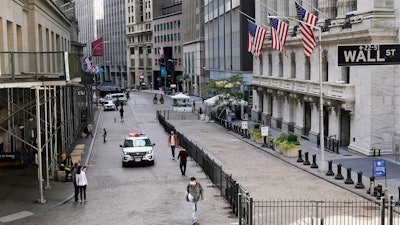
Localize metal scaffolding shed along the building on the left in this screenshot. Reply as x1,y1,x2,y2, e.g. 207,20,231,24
0,52,93,203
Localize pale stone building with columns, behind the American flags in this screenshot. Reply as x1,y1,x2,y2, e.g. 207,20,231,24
251,0,400,160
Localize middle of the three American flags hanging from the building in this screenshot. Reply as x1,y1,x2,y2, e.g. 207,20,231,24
269,18,289,52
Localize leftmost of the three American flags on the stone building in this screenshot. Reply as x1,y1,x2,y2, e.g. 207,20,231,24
247,20,267,59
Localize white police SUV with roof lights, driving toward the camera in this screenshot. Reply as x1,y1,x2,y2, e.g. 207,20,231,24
120,132,155,167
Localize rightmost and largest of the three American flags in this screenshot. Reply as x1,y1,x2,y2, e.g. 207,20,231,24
295,2,318,57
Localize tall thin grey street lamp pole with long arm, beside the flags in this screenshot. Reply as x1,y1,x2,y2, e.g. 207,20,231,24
268,16,327,172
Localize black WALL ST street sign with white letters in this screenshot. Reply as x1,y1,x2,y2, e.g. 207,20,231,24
338,44,400,66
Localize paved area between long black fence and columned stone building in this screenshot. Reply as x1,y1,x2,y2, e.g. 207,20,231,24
159,93,400,200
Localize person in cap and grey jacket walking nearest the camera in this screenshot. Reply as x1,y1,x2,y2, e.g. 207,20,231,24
186,177,204,225
